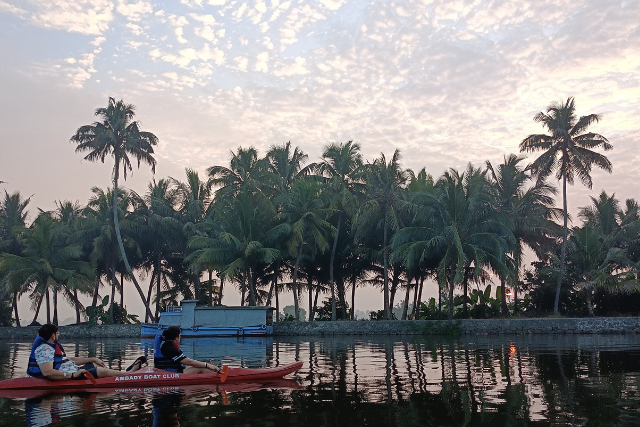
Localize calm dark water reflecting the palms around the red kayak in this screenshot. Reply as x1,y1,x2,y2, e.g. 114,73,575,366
0,335,640,427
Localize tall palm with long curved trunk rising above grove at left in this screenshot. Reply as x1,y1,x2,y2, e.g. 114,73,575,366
71,97,158,319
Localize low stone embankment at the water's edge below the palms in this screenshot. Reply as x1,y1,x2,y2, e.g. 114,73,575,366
0,317,640,341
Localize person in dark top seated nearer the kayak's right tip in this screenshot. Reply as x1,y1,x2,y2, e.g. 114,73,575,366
153,326,219,374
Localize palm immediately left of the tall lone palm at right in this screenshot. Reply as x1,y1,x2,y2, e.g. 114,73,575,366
486,154,561,316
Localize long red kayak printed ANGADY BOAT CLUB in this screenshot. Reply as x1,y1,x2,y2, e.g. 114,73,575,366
0,362,302,391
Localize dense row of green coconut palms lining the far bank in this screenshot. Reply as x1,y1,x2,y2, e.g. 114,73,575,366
0,98,640,326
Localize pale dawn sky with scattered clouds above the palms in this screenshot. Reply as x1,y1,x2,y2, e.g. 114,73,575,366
0,0,640,320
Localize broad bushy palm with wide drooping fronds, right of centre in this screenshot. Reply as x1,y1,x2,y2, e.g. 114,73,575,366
394,165,512,320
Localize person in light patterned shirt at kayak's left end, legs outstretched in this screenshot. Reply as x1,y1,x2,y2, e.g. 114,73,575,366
27,324,147,380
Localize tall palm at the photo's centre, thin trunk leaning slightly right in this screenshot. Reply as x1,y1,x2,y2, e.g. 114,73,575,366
319,141,362,320
